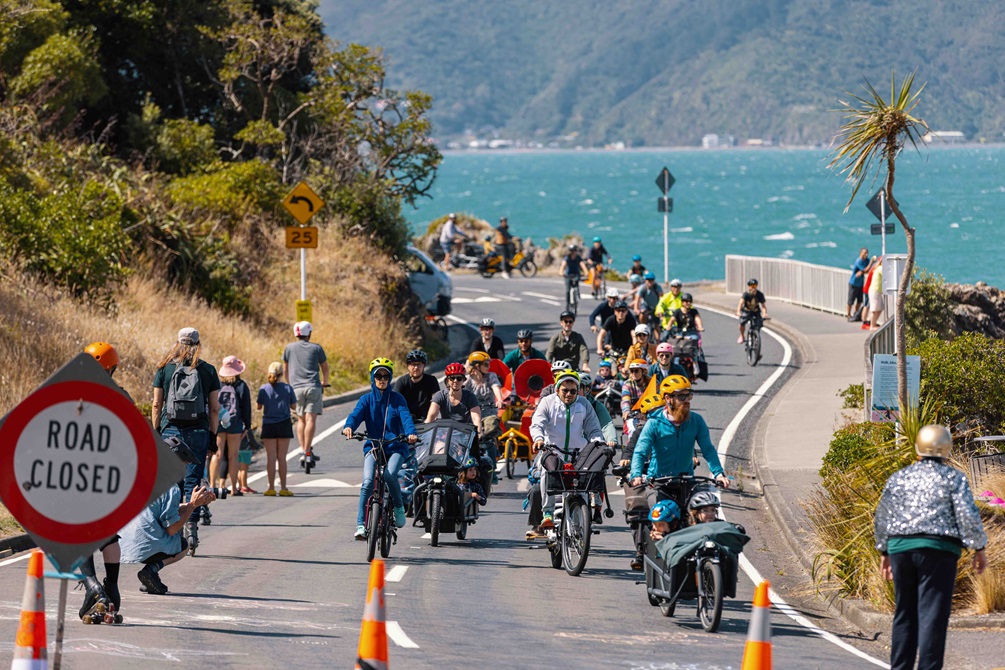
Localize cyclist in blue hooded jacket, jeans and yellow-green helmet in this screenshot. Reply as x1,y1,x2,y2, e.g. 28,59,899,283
342,358,418,540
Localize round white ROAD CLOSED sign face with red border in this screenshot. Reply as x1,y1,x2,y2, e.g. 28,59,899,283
0,381,158,544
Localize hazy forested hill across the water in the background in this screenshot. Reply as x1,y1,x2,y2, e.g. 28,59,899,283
320,0,1005,146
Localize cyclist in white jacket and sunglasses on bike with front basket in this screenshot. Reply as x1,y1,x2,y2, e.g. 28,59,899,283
531,370,605,528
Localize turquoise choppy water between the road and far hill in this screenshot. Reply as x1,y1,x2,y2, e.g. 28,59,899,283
406,147,1005,286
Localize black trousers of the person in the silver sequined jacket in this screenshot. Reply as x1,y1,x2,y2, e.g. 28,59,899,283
889,549,957,670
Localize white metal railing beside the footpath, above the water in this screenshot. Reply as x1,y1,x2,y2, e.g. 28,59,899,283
726,255,851,314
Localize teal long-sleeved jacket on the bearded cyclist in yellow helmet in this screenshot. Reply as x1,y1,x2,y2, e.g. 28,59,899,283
630,411,723,478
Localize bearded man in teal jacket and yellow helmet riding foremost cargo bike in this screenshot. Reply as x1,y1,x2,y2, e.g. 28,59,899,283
630,375,730,488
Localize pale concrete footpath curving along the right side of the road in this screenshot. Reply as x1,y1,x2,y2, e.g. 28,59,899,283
692,286,1005,668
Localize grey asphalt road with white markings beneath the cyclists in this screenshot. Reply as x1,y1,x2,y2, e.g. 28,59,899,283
0,275,892,670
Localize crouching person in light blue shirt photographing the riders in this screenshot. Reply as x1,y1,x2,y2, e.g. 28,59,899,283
119,436,216,596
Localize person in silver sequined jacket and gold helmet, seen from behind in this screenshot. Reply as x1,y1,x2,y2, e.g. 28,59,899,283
875,426,988,670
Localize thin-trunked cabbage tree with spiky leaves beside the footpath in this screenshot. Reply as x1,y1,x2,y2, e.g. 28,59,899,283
828,70,928,412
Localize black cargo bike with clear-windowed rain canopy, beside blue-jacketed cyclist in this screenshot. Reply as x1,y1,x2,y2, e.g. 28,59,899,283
413,419,478,546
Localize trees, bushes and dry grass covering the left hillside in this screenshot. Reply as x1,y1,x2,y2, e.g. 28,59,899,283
0,0,440,411
